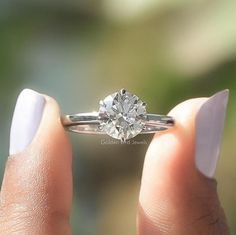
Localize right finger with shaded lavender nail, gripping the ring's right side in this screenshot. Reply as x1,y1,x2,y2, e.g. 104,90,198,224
138,91,229,235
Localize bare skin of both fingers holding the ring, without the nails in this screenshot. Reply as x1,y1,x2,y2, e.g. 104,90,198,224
0,96,230,235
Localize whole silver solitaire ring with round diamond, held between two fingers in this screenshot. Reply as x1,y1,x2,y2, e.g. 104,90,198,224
62,89,175,142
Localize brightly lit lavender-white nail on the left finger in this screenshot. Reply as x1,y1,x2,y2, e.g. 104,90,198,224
9,89,46,155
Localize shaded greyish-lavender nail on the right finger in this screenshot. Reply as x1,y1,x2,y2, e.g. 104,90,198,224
195,90,229,178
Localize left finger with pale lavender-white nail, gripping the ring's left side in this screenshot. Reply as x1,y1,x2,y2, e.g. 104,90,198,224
0,89,72,235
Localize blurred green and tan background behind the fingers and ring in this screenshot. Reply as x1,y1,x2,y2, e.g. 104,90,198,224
0,0,236,235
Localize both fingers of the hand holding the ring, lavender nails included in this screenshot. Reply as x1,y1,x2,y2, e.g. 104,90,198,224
0,90,229,235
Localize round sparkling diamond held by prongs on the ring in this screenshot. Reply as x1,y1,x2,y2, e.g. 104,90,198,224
99,89,147,141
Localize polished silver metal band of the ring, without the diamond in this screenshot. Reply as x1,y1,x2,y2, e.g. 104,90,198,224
62,112,175,134
